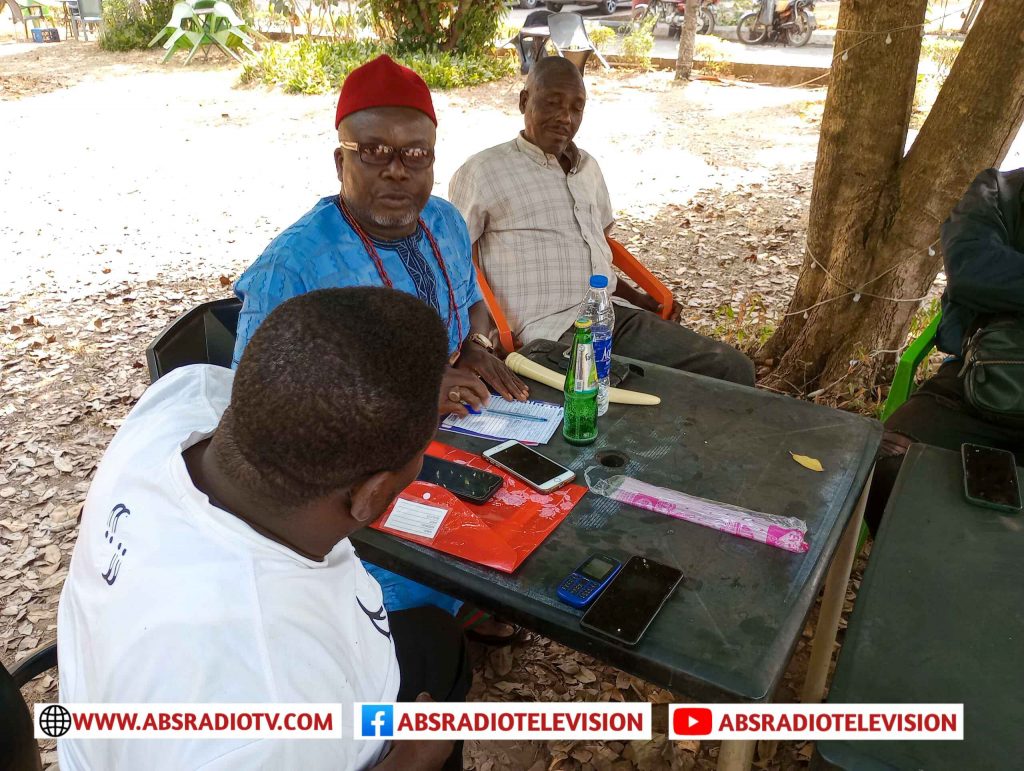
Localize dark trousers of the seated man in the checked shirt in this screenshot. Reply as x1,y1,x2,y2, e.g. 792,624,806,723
559,305,754,386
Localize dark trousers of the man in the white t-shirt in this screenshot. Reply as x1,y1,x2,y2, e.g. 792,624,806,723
388,605,473,771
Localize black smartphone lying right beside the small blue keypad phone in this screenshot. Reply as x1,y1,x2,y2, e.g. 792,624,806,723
580,557,683,645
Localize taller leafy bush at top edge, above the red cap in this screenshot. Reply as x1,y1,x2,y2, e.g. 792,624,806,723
367,0,508,54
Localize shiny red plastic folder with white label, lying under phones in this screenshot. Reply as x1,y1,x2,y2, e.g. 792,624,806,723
371,441,587,573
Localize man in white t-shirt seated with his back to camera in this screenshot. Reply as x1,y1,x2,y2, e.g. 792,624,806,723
57,288,470,771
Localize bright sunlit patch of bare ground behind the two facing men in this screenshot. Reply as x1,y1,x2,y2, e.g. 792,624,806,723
0,52,820,296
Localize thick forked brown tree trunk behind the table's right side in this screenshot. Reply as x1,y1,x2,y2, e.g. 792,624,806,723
762,0,1024,392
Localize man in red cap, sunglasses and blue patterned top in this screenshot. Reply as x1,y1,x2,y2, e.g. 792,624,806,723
234,56,527,630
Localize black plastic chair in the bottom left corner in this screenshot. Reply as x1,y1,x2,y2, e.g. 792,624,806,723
0,643,57,771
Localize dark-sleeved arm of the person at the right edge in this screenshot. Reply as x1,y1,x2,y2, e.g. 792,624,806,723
942,169,1024,313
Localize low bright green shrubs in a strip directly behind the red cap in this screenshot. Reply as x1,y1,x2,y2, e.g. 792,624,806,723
242,38,515,94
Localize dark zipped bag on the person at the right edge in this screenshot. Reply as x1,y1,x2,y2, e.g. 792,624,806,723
961,315,1024,428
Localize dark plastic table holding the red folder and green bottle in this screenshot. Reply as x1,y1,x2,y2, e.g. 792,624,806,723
351,346,882,767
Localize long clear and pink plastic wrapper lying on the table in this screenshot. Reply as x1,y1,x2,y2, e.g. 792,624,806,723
590,475,811,554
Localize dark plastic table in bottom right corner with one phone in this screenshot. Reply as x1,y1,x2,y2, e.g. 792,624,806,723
817,444,1024,771
